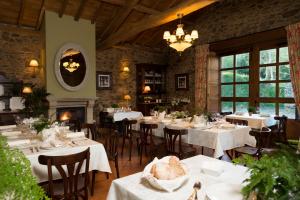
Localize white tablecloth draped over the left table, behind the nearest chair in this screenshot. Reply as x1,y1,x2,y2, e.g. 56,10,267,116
22,139,111,182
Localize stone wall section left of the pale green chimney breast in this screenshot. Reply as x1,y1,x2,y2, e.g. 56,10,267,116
0,25,45,86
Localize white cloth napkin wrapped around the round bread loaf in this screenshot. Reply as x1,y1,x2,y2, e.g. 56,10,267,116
142,156,189,192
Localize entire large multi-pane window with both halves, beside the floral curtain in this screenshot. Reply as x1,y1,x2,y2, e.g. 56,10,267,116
220,46,296,118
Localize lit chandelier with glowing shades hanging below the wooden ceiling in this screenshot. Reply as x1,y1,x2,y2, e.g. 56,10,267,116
163,14,198,53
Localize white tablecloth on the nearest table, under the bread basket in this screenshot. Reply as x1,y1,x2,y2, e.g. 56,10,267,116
107,155,249,200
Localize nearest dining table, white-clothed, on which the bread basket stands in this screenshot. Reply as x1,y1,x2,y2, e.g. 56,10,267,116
107,155,249,200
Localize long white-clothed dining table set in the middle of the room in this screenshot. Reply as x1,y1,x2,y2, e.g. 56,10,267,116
135,116,256,158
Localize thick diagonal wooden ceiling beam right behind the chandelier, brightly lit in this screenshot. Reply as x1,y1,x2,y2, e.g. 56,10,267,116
97,0,219,49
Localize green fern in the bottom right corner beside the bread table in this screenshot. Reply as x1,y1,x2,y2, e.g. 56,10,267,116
234,145,300,200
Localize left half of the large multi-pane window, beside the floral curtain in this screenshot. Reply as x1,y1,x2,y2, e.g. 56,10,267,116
220,52,250,112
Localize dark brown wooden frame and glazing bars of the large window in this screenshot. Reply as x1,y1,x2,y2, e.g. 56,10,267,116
219,42,298,119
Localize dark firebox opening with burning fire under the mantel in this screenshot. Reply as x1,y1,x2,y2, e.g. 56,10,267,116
56,107,86,123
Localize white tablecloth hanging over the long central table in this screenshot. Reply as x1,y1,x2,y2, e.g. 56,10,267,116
137,119,256,158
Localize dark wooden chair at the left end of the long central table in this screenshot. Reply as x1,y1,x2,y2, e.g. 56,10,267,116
137,123,158,165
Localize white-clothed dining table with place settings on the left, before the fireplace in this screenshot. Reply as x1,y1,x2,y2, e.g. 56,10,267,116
0,125,111,183
